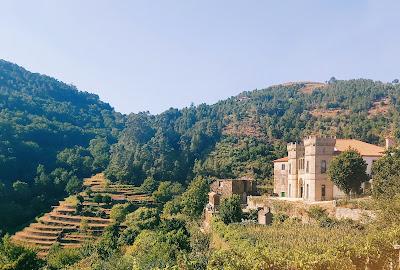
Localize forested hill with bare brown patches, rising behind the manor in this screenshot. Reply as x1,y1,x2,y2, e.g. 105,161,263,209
107,79,400,188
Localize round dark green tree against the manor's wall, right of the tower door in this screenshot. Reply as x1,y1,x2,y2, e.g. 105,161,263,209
328,149,369,196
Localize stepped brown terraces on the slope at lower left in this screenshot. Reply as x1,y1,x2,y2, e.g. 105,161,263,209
12,174,152,257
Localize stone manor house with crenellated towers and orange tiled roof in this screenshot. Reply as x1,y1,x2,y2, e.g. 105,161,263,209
274,136,393,201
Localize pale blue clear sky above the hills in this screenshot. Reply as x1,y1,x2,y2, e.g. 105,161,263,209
0,0,400,113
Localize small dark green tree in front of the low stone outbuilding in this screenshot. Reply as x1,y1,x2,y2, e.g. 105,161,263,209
219,194,243,224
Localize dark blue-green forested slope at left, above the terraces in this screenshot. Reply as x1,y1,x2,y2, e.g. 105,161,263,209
0,60,123,233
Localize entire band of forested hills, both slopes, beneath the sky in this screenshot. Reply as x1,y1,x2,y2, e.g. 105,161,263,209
0,61,400,236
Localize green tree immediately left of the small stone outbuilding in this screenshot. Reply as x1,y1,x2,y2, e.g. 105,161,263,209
181,177,210,218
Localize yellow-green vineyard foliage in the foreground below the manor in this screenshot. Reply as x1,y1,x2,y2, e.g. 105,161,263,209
208,221,400,270
